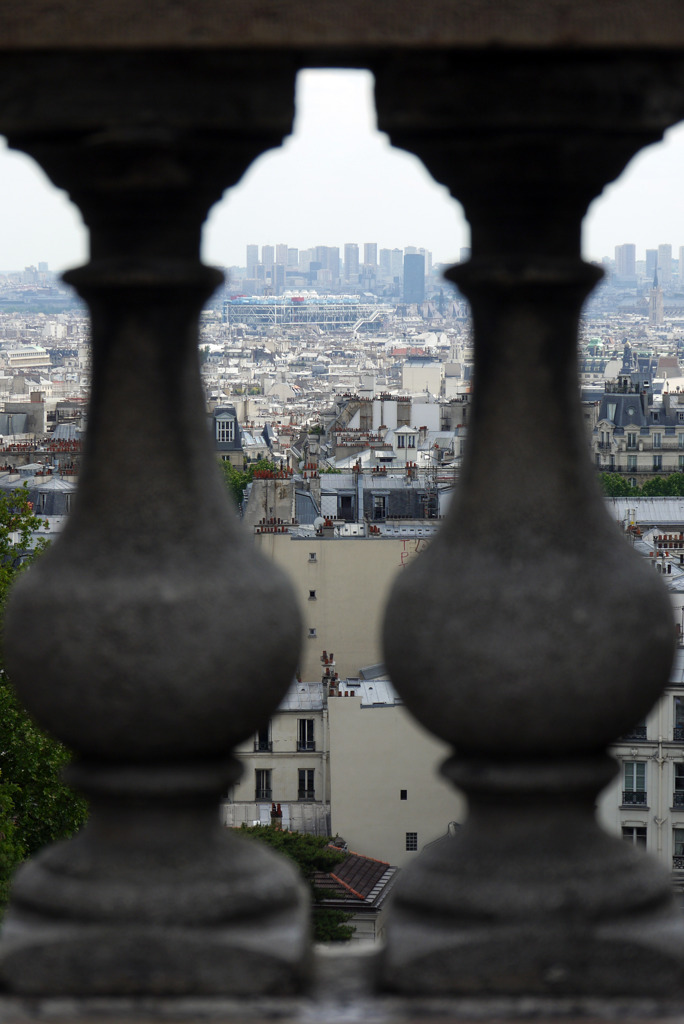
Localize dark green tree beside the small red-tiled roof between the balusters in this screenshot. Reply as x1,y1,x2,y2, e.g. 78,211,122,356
240,825,354,942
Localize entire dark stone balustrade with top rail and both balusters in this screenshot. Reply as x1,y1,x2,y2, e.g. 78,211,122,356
0,0,684,1019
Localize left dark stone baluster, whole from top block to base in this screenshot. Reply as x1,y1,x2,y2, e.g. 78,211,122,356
0,54,308,995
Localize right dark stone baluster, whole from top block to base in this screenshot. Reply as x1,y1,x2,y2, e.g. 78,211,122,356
378,53,684,994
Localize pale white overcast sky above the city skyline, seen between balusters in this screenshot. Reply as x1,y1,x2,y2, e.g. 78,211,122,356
0,71,684,270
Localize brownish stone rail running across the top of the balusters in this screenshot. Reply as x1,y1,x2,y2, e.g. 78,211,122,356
0,0,684,50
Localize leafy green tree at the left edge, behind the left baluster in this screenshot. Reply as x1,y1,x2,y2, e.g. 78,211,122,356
0,485,87,913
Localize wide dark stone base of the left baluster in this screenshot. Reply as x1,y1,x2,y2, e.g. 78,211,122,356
0,765,310,995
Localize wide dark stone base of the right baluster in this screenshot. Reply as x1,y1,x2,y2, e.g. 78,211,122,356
380,757,684,997
